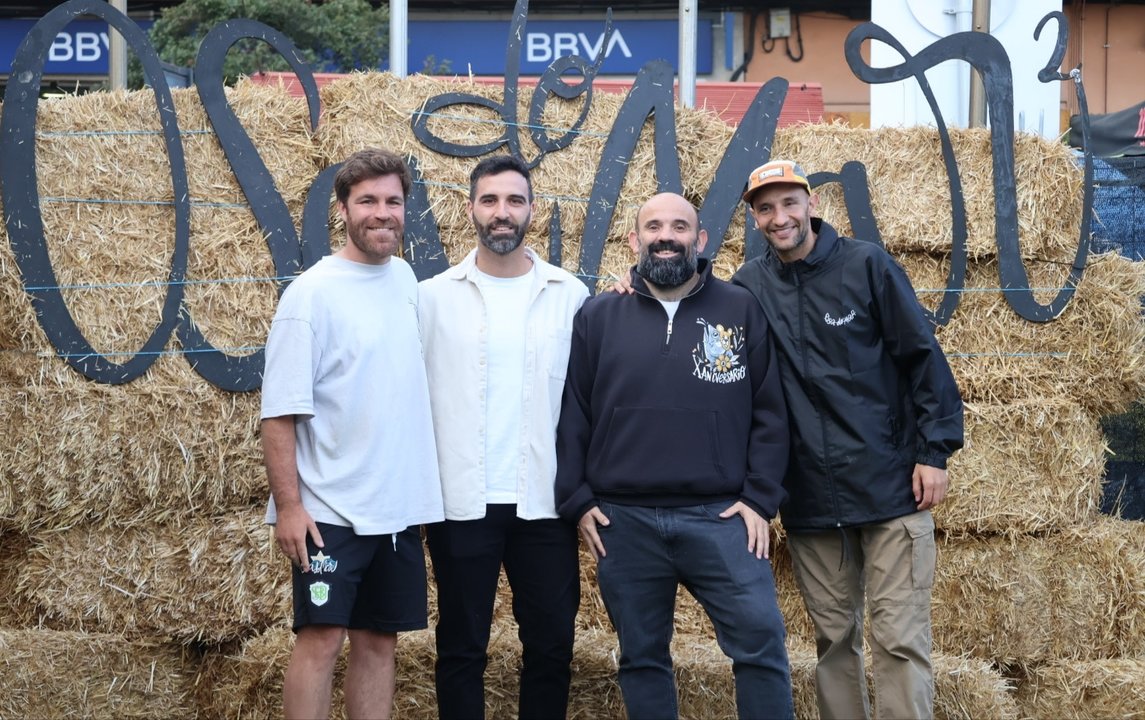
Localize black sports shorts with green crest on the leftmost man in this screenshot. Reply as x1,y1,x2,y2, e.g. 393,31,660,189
293,522,428,633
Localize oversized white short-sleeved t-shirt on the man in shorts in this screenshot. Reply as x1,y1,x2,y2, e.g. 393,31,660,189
261,255,444,535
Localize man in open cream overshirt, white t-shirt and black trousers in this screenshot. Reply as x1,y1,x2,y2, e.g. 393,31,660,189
420,155,589,720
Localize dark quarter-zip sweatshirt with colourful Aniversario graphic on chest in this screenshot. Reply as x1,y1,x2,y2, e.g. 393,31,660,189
555,260,790,522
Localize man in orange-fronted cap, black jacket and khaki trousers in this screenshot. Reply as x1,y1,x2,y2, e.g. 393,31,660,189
733,160,963,720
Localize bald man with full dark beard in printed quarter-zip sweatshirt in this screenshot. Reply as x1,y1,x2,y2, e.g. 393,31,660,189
555,193,793,720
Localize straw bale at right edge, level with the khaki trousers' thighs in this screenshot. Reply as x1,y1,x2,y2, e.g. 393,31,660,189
931,519,1145,664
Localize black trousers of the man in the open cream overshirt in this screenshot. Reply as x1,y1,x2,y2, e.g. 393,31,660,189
426,505,581,720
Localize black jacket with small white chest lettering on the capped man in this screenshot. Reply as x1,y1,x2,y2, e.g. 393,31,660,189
732,217,963,530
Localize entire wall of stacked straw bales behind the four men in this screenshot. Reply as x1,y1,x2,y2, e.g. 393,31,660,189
0,73,1145,718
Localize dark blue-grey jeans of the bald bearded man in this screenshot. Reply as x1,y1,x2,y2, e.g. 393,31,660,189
597,503,795,720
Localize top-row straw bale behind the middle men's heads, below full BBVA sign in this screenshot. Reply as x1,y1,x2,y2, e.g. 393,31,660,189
316,73,743,275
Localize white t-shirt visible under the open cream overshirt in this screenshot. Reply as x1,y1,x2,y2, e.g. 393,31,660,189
477,269,534,505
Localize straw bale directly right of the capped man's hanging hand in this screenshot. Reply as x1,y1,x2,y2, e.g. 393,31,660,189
934,399,1105,536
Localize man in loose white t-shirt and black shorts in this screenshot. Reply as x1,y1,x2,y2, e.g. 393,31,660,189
261,149,443,718
